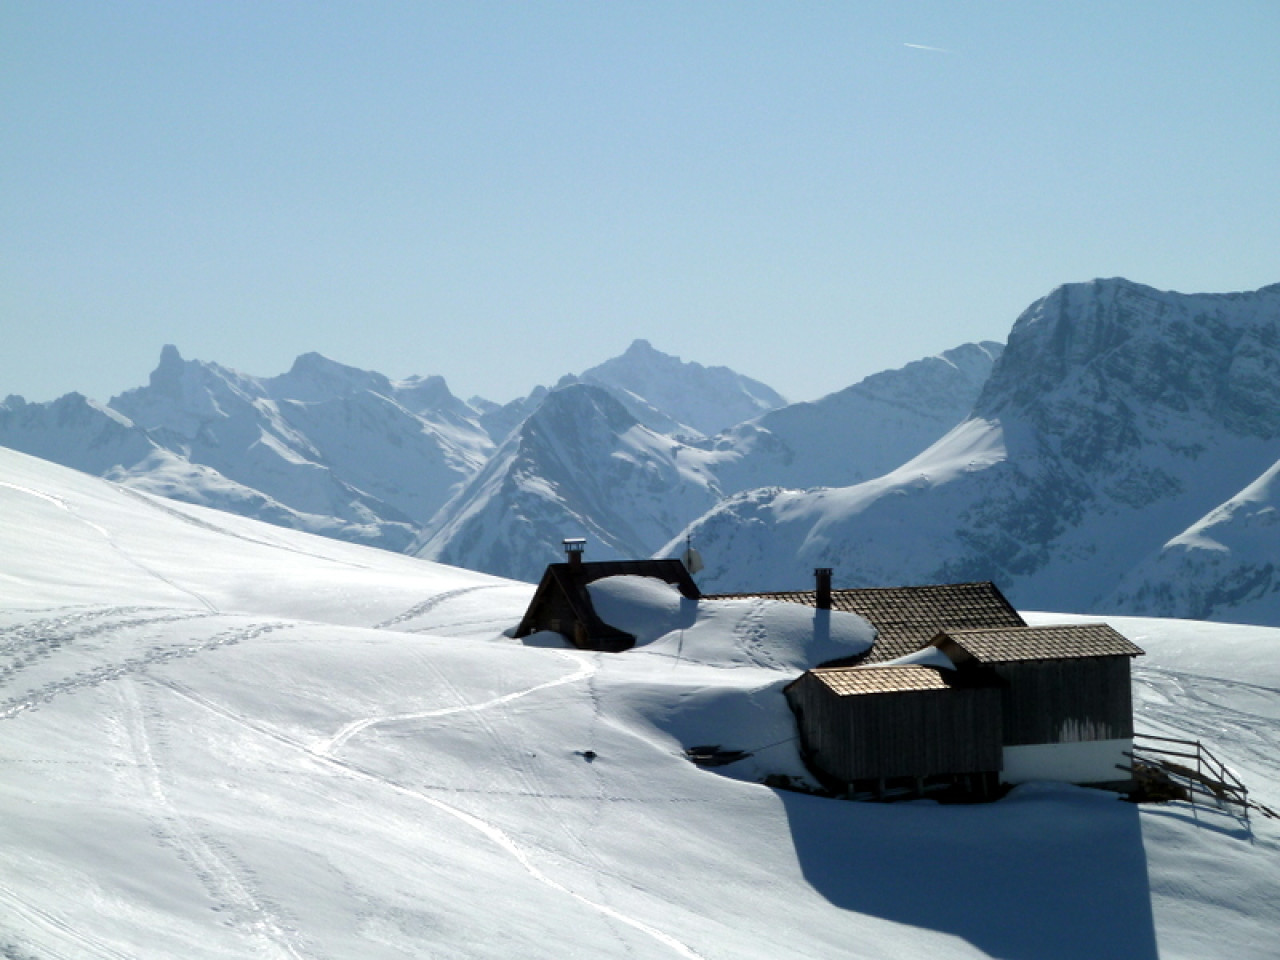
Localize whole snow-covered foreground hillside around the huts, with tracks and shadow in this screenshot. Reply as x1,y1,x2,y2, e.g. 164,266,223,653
0,449,1280,960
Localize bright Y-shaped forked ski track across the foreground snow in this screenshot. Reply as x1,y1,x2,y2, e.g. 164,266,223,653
156,650,705,960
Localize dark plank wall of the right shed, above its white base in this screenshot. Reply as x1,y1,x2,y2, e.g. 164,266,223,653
989,657,1133,746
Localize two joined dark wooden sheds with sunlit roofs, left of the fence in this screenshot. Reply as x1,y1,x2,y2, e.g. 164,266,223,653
785,623,1142,796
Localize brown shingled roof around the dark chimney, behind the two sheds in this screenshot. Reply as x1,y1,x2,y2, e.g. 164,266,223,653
709,581,1027,663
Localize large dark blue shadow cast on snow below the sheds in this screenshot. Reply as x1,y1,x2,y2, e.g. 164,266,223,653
778,785,1157,960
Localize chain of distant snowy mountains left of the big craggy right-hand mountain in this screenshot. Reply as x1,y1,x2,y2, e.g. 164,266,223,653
0,340,998,579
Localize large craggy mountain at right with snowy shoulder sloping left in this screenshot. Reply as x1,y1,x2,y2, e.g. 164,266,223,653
667,280,1280,616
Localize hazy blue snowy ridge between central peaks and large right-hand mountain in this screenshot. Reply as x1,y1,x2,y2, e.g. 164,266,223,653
713,340,1004,493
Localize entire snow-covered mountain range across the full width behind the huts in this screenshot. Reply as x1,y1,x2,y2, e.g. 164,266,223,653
0,279,1280,623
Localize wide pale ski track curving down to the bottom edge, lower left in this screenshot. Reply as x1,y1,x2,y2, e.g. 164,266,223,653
120,677,303,960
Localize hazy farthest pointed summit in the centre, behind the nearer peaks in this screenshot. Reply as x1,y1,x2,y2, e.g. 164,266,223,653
579,340,786,435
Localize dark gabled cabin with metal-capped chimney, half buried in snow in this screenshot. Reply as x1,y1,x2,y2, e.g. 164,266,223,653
515,539,701,653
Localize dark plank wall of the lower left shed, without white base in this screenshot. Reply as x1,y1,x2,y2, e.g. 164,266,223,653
786,675,1001,782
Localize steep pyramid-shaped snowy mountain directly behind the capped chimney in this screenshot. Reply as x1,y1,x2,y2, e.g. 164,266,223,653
413,383,718,580
